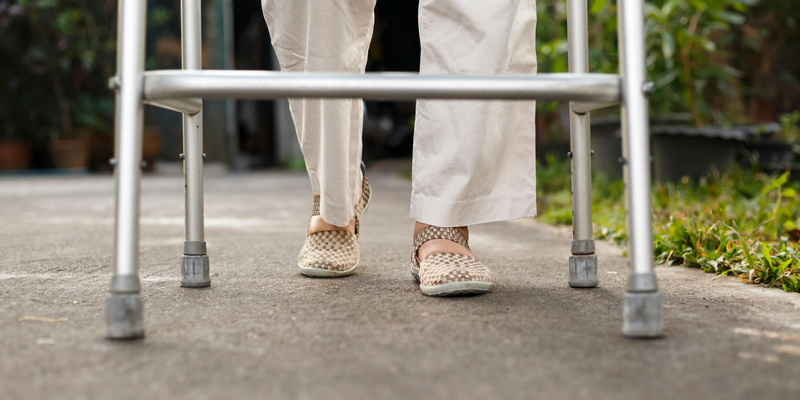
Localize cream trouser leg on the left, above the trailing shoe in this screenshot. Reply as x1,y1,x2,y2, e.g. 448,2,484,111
261,0,375,226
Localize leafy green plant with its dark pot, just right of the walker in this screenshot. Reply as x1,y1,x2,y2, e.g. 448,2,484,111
646,0,774,181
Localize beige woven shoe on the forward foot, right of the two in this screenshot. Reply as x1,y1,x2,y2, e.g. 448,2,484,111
411,226,492,296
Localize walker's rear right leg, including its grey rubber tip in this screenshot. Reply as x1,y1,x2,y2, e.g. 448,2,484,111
567,0,599,288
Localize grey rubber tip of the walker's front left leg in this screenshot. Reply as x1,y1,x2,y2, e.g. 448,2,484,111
106,293,144,340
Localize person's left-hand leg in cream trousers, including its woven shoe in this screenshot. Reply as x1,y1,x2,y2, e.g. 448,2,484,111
262,0,375,276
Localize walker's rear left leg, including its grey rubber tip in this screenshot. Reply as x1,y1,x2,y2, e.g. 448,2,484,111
181,0,211,288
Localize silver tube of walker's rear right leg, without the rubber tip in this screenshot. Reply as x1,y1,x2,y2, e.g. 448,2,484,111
567,0,593,241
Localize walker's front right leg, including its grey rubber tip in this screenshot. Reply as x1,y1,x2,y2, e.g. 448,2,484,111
617,0,664,338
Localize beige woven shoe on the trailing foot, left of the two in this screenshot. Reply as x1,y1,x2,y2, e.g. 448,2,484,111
297,165,372,278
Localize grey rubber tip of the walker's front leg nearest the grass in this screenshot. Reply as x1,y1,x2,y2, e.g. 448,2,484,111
622,292,664,339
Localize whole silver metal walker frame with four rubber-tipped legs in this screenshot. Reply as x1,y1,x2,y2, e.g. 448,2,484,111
106,0,663,339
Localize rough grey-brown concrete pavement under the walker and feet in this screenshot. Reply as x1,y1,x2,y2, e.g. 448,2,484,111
0,164,800,400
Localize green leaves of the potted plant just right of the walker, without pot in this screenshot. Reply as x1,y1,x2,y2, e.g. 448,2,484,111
645,0,757,127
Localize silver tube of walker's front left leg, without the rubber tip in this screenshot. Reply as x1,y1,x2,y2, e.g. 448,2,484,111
114,0,147,276
